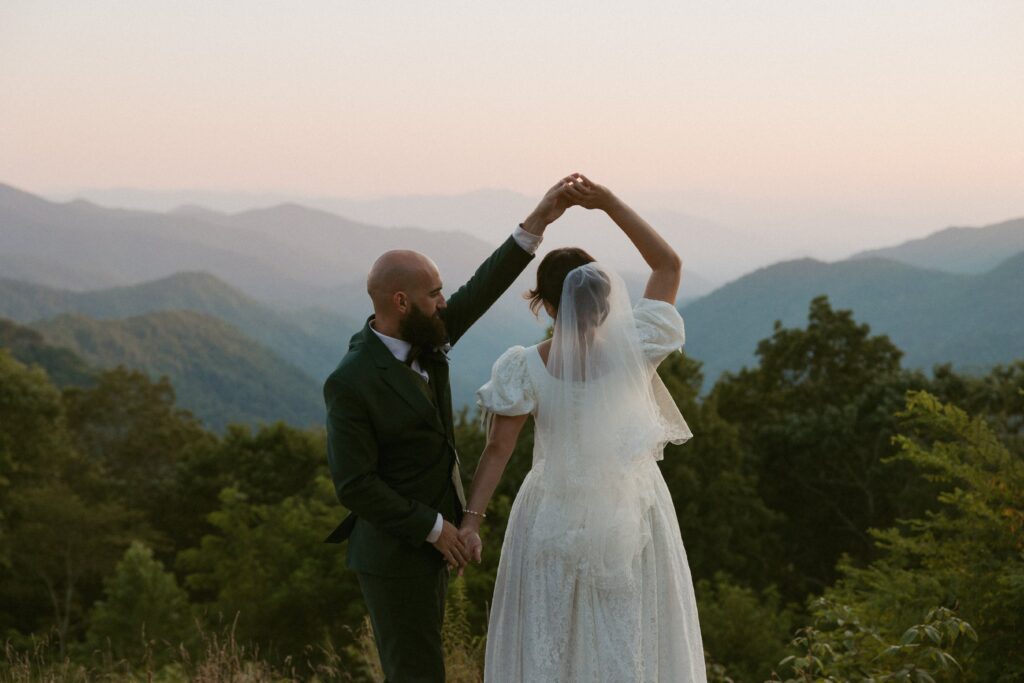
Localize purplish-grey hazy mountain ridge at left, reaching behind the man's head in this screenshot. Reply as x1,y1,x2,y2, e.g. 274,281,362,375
0,185,499,310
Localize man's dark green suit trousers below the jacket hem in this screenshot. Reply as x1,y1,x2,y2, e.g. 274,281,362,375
357,567,449,683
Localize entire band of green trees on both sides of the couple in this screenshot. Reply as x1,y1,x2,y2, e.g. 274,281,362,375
0,298,1024,683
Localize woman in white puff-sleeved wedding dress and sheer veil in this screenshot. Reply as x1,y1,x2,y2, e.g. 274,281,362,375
462,176,706,683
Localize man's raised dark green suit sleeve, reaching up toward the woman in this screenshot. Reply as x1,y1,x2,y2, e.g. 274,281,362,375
443,238,534,345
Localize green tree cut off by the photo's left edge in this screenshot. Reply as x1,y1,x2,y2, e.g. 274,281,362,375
0,350,138,652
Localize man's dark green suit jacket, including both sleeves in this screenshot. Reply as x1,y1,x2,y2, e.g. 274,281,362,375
324,238,534,577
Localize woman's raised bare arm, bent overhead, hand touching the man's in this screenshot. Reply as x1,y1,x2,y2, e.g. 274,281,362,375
565,174,683,304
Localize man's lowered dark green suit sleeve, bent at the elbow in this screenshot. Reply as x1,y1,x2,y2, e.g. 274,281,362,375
324,380,437,546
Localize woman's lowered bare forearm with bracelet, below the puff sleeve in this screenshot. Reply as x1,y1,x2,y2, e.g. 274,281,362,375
459,415,528,562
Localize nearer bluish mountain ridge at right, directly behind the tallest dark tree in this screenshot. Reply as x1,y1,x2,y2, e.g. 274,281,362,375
682,253,1024,382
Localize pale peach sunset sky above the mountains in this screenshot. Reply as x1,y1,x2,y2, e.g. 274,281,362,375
0,0,1024,245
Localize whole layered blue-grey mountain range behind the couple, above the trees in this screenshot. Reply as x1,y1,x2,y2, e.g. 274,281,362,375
0,180,1024,426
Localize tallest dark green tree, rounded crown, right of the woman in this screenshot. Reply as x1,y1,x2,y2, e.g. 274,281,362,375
711,297,923,600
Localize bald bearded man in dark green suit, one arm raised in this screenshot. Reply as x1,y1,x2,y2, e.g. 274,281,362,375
324,176,572,683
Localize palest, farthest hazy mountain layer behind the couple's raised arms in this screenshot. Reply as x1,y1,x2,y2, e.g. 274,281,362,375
48,183,724,292
